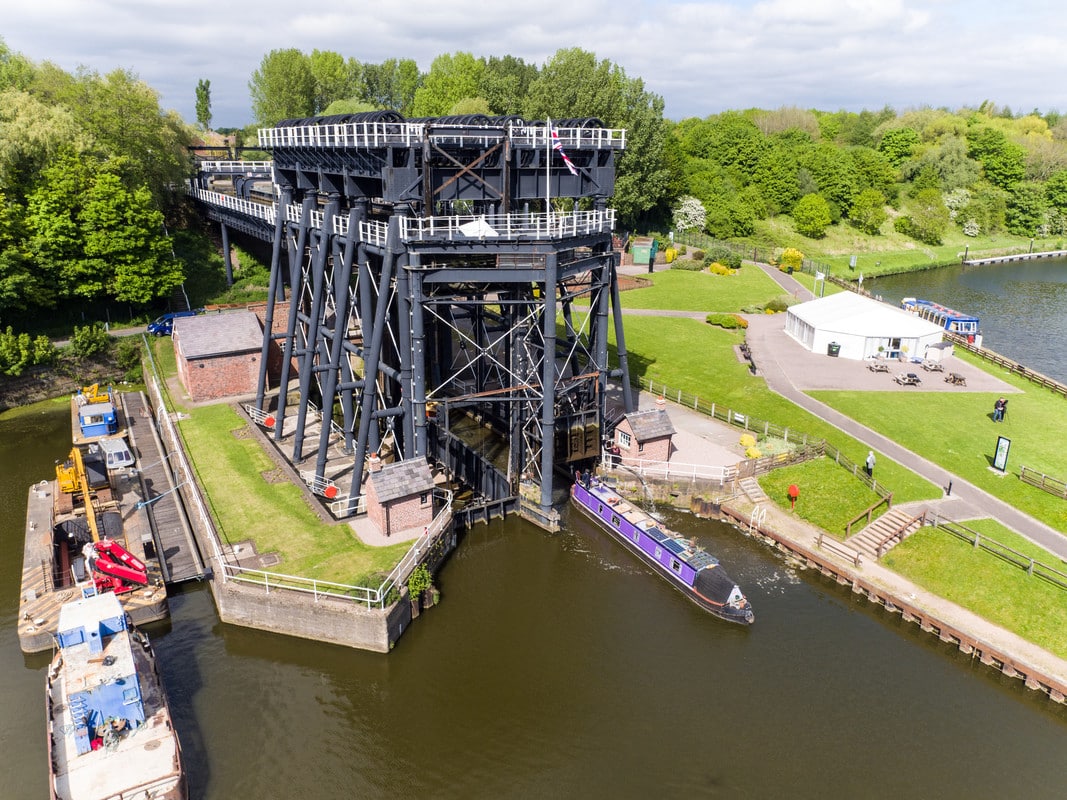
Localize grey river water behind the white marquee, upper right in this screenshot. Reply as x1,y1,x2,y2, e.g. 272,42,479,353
863,258,1067,383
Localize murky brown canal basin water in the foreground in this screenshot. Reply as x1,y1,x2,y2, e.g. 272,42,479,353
0,404,1067,800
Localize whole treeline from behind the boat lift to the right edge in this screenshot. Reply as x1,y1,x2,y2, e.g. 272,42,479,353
248,49,1067,244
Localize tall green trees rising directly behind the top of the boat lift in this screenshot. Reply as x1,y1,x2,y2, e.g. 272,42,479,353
243,48,682,228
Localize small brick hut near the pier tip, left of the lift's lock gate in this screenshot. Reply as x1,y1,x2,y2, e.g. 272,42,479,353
367,459,433,537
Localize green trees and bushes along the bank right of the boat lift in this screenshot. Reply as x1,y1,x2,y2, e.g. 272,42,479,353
671,103,1067,244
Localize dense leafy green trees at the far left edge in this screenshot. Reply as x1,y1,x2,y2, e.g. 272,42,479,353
0,39,191,330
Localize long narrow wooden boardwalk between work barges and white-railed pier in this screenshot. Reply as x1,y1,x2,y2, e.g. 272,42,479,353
121,393,206,583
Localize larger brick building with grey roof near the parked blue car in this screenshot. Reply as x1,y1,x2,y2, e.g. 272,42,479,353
173,310,264,401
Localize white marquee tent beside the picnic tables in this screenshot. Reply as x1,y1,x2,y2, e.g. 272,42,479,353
785,291,944,359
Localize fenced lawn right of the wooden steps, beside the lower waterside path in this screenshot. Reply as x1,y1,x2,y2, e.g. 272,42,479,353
882,519,1067,658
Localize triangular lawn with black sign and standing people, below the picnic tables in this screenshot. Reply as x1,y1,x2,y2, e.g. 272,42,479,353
811,367,1067,532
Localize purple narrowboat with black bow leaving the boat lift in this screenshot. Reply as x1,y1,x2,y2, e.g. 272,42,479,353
571,478,755,625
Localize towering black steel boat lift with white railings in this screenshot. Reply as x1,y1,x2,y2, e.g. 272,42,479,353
193,112,634,526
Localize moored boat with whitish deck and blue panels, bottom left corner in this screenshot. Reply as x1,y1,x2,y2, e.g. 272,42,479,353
46,592,188,800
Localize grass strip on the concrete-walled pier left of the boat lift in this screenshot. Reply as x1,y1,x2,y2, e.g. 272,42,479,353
179,404,411,587
